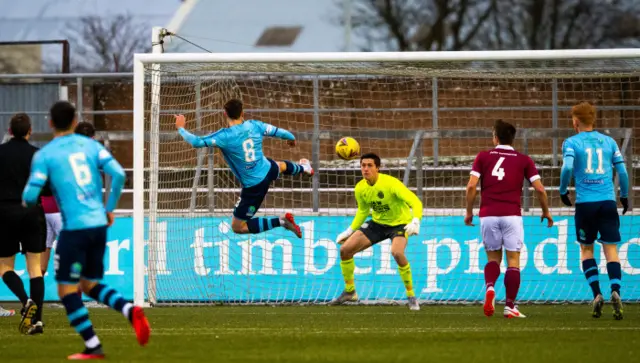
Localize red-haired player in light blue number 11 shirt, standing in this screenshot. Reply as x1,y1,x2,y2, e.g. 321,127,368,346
560,102,629,320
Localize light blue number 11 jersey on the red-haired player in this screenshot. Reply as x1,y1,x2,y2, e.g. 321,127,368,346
560,131,629,203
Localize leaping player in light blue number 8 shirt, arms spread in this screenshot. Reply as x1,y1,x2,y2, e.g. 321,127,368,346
176,99,313,238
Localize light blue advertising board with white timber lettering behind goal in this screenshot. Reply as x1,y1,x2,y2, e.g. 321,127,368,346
0,216,640,302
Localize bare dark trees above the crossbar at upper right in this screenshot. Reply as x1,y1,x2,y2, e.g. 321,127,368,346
337,0,640,51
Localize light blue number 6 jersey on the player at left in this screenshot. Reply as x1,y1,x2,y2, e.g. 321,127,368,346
22,134,125,230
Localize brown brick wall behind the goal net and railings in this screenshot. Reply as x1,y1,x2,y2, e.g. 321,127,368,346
80,77,640,167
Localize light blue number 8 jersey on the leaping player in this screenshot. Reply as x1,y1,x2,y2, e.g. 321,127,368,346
178,120,295,188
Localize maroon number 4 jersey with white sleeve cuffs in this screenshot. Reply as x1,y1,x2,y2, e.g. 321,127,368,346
471,145,540,217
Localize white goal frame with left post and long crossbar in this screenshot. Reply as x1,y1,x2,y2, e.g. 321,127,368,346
133,49,640,305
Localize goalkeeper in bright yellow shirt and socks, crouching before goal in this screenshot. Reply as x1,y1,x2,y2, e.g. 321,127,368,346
333,153,422,310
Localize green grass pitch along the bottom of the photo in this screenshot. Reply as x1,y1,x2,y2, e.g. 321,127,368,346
0,305,640,363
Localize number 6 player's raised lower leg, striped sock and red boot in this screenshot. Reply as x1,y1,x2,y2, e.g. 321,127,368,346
85,284,151,346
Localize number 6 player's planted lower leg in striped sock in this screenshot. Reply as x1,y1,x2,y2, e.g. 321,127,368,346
58,292,104,360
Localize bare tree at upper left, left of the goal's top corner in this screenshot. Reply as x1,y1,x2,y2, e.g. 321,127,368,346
66,14,151,72
